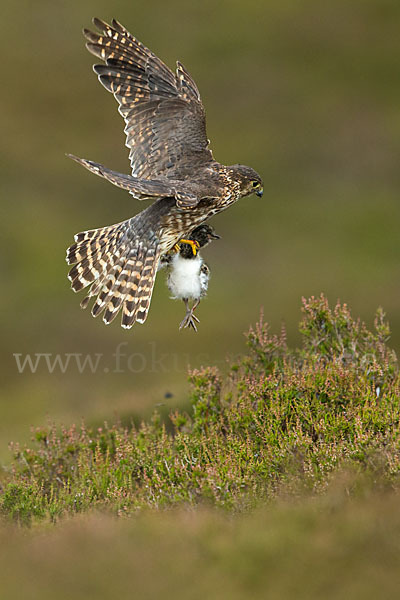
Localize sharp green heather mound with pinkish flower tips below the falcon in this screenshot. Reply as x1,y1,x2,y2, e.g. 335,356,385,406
0,296,400,524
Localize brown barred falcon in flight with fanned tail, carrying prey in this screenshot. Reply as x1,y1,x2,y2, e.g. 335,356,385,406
67,19,263,328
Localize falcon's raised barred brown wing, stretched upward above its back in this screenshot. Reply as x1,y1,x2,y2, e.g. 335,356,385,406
84,19,213,179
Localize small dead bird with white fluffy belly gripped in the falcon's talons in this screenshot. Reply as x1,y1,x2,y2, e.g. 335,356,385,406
161,224,220,331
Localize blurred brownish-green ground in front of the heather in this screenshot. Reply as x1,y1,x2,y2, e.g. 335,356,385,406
0,486,400,600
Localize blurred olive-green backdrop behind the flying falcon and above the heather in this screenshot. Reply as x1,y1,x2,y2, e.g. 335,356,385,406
0,0,400,460
